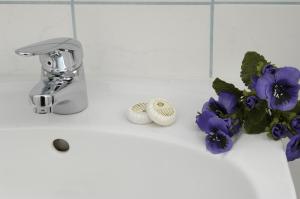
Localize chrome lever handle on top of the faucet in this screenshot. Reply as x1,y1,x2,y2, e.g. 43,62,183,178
15,38,83,73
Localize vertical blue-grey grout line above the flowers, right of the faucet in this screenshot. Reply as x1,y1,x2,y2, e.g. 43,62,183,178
209,0,215,78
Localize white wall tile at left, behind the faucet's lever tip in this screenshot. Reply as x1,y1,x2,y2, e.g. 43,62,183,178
0,4,72,76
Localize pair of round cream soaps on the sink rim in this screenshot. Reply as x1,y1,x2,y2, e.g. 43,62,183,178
127,98,176,126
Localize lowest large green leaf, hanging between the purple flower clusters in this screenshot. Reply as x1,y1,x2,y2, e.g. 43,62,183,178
244,101,271,134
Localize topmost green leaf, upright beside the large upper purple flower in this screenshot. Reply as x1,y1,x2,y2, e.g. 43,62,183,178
241,52,268,88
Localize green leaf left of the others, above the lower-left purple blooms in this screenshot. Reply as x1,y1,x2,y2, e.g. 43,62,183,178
212,78,243,98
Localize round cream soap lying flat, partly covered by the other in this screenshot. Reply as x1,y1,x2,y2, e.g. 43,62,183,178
127,102,152,124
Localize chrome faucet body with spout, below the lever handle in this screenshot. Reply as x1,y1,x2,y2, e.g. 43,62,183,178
29,68,88,115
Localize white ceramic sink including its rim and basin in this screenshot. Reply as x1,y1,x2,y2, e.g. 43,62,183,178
0,77,296,199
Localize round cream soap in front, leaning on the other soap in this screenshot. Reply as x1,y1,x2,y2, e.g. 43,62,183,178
146,98,176,126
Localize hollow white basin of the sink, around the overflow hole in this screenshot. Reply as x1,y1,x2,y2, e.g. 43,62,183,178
0,129,256,199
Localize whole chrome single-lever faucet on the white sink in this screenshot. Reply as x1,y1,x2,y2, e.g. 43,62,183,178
15,38,88,115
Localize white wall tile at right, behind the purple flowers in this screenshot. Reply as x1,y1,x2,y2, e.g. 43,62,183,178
214,5,300,85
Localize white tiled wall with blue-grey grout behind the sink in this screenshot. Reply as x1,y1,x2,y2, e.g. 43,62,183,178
0,0,300,195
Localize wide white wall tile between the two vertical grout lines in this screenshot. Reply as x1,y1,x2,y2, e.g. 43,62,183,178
75,5,209,78
